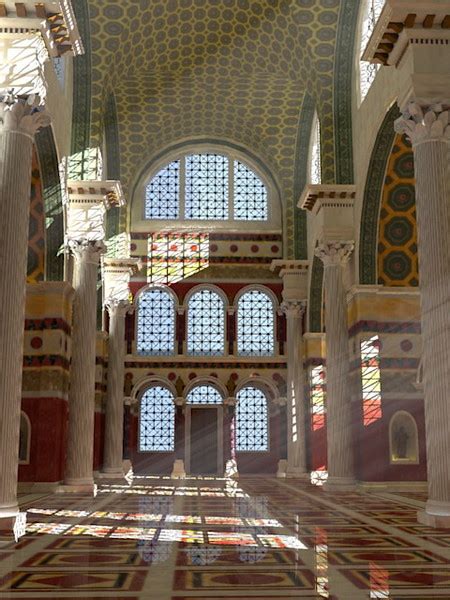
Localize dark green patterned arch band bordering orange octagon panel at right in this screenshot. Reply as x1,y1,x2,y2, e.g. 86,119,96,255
359,104,400,284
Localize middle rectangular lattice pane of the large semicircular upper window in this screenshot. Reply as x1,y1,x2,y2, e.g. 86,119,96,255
185,154,228,220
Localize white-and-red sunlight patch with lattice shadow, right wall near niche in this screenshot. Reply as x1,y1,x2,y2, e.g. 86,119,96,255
361,335,382,426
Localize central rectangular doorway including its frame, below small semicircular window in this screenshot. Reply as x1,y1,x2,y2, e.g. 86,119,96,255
185,406,223,475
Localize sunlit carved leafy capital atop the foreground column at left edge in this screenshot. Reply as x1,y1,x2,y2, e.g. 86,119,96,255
0,96,50,138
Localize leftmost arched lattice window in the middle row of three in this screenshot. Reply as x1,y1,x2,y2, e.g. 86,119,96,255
136,288,175,356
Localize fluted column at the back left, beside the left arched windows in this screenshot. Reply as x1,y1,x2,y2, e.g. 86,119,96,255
102,300,131,477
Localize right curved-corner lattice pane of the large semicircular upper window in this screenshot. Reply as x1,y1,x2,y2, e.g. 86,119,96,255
233,160,268,221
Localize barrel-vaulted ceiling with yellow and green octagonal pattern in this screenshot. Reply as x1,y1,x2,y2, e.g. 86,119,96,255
79,0,358,255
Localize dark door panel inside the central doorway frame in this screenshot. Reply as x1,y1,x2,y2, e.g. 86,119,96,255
191,408,218,475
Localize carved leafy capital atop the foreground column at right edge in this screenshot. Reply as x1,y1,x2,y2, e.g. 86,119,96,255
394,102,450,146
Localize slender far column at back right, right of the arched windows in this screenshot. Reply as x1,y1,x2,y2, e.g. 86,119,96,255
281,300,307,477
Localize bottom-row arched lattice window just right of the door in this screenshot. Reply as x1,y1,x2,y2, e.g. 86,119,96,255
236,387,269,452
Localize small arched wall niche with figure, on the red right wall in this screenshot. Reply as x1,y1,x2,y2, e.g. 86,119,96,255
389,410,420,464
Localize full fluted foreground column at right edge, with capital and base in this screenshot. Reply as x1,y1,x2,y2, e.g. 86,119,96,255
395,103,450,527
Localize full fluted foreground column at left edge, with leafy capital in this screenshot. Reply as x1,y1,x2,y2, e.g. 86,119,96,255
0,98,50,518
